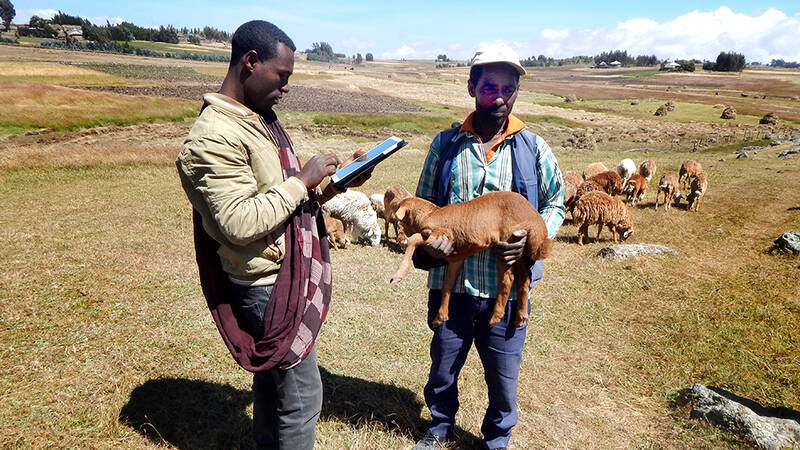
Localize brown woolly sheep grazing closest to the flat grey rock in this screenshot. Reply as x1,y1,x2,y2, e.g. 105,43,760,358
573,191,633,245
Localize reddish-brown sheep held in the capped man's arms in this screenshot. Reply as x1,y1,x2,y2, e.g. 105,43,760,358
390,191,553,328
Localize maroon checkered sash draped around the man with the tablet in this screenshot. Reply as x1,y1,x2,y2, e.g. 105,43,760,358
193,115,332,372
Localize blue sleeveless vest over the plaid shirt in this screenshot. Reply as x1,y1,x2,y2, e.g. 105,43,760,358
434,127,542,287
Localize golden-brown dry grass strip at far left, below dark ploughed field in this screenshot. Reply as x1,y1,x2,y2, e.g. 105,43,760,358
0,83,197,130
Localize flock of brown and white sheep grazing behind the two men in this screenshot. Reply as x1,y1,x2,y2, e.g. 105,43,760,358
322,158,708,248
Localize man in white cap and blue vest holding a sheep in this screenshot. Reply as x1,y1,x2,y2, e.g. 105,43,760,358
414,43,564,450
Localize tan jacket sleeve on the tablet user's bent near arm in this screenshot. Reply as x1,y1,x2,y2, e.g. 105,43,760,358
179,135,308,246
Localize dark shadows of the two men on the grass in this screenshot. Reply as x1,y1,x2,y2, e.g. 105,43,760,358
119,367,480,449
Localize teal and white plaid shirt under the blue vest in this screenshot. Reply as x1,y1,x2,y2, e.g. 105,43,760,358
416,114,564,299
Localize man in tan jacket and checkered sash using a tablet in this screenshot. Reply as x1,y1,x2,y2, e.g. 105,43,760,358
176,21,371,449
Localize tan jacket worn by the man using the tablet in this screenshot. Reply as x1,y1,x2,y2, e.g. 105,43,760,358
175,94,336,280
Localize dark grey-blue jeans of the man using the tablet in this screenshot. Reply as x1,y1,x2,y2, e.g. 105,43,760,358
234,285,322,450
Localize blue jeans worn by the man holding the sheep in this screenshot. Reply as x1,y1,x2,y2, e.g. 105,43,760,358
425,290,530,448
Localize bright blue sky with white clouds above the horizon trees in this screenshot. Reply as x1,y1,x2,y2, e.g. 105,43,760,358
12,0,800,63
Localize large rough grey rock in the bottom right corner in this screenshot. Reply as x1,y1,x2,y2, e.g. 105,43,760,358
690,384,800,450
